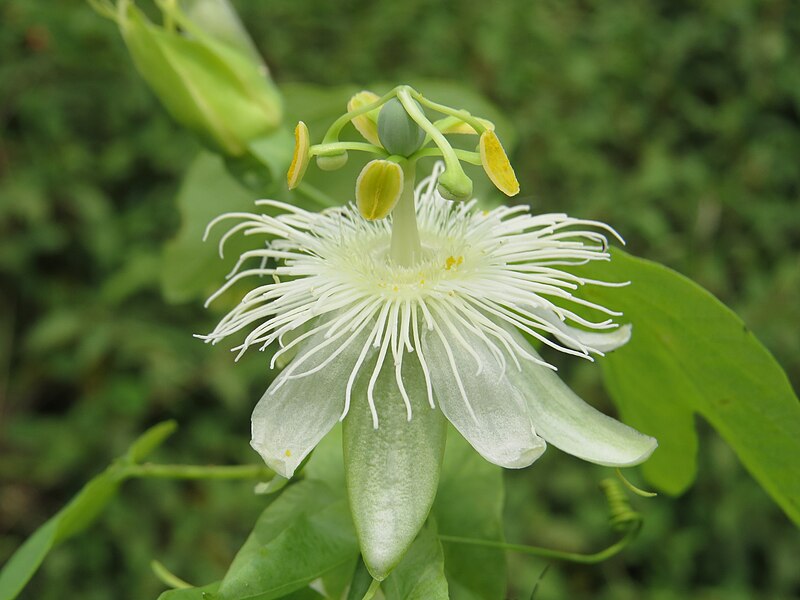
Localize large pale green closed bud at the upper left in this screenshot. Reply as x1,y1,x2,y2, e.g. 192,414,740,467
97,0,282,156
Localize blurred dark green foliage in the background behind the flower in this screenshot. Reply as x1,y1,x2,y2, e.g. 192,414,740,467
0,0,800,600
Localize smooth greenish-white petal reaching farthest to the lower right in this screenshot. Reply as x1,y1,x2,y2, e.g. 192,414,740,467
510,331,658,467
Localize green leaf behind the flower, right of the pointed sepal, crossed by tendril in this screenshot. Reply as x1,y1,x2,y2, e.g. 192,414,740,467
433,427,506,600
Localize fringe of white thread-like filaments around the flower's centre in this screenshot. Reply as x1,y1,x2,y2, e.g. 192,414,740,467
198,165,621,427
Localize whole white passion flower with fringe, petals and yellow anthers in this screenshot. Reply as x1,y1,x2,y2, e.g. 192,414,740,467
205,85,656,580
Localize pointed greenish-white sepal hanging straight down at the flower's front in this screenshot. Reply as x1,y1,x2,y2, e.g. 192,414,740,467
343,356,446,580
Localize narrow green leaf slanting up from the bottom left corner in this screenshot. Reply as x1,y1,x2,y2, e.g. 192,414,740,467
0,421,175,600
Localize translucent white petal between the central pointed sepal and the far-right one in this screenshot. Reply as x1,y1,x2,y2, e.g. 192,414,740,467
422,314,546,469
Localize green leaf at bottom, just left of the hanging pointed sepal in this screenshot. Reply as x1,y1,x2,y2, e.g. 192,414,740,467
219,480,358,600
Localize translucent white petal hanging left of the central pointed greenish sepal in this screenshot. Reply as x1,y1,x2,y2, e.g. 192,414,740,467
250,330,367,479
